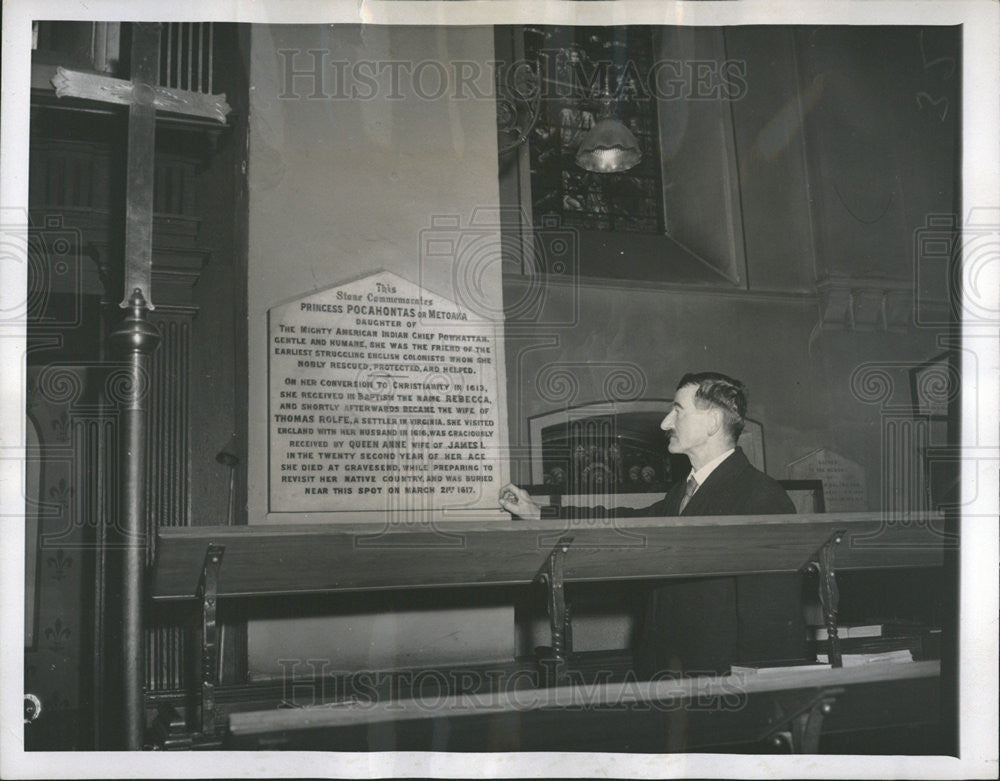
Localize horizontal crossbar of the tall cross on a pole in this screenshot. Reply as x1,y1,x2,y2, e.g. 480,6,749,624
52,67,232,124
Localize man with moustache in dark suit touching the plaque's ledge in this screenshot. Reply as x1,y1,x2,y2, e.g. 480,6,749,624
500,372,806,676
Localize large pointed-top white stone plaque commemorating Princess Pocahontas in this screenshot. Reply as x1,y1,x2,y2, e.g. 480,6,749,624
268,271,506,512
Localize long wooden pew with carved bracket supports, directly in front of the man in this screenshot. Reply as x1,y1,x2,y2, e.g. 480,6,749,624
151,513,957,746
